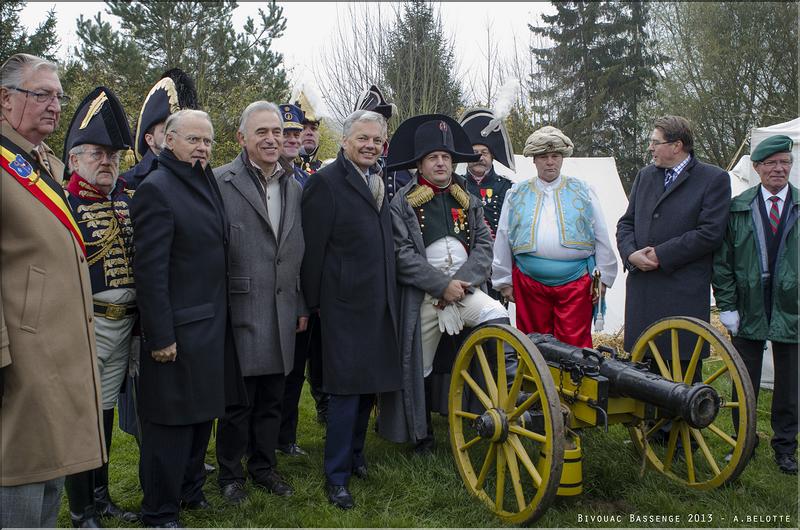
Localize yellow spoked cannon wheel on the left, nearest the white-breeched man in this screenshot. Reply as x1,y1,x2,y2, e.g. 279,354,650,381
449,325,564,524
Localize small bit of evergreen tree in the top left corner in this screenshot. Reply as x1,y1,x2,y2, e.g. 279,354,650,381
0,0,58,64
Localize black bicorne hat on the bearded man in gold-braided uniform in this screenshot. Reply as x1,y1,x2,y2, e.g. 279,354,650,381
64,86,133,164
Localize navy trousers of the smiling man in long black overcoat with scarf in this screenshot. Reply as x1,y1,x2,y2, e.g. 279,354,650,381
324,394,375,486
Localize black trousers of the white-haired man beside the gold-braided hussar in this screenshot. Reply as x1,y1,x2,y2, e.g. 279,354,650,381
139,420,213,526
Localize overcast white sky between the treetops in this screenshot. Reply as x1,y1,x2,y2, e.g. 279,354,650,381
20,2,552,93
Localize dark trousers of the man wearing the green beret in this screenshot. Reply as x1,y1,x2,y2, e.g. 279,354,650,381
733,337,800,455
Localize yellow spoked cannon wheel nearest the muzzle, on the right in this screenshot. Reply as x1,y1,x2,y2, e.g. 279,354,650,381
630,317,756,490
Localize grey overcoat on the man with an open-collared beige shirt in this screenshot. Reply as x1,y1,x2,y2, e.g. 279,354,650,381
214,154,308,377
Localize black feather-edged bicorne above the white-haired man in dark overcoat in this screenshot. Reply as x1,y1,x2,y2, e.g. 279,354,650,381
134,68,198,160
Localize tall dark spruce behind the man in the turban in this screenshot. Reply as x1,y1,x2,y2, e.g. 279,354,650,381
530,2,663,188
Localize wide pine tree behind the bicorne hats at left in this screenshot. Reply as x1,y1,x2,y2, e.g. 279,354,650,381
65,0,289,163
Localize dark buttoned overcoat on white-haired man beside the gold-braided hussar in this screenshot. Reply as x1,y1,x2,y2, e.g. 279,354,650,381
131,150,241,425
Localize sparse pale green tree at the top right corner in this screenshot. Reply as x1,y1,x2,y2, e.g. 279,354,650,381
654,2,798,168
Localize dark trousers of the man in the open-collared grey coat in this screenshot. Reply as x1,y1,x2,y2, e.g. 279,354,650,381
217,374,286,486
